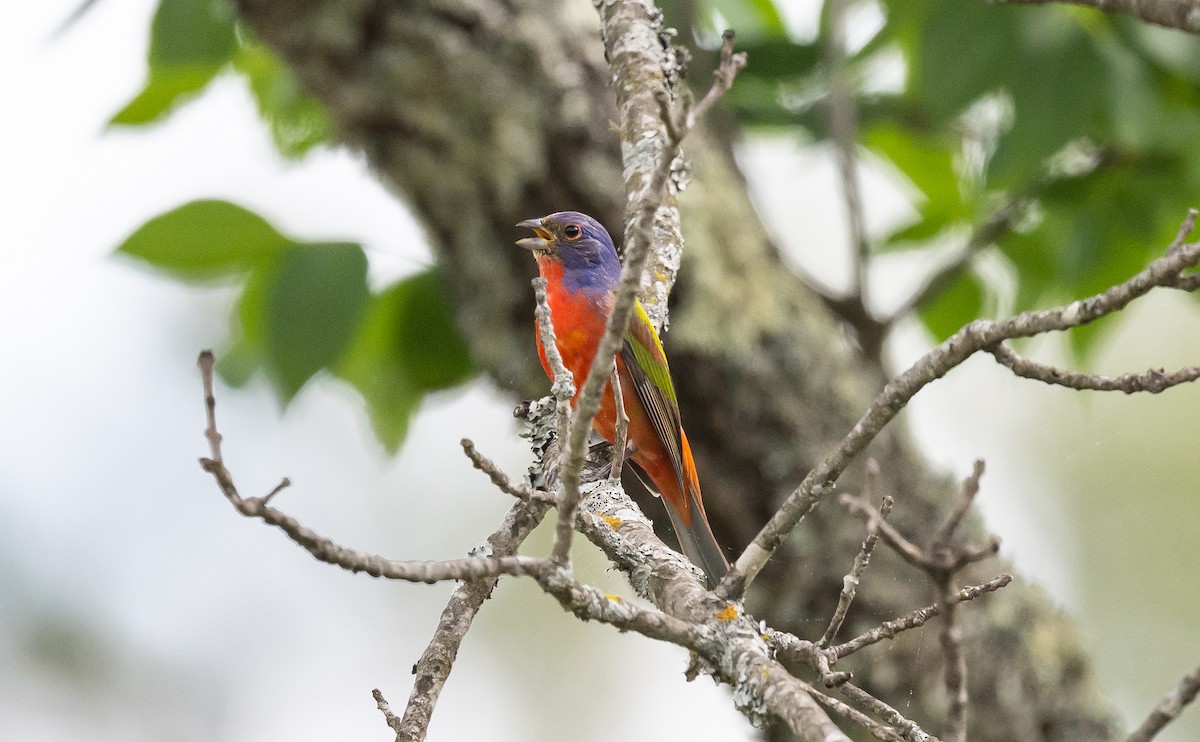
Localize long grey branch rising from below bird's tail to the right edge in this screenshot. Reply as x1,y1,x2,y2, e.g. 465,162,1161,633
719,209,1200,597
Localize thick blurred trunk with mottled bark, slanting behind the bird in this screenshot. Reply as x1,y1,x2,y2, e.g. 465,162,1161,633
231,0,1116,742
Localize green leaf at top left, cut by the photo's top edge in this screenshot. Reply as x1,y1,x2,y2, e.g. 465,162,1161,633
109,0,238,126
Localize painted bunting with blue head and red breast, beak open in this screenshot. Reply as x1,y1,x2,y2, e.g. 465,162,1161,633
517,211,730,586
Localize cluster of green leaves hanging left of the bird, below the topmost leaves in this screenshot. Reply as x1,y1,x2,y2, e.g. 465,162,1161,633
118,201,475,451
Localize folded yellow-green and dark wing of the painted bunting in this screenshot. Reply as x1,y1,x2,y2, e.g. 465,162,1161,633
620,296,685,495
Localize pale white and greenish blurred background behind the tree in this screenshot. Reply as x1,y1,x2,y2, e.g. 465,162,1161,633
0,0,1200,741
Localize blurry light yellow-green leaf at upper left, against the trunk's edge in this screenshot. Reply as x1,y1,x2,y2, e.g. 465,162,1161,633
234,43,331,158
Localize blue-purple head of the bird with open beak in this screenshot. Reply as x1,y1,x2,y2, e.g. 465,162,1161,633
517,211,620,292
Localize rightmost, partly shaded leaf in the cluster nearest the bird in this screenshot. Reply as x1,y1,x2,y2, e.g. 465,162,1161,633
337,270,475,453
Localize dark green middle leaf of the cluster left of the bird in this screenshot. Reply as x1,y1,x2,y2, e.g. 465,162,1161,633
263,243,370,401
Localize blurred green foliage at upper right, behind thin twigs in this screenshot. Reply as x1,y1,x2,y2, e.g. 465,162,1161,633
696,0,1200,343
